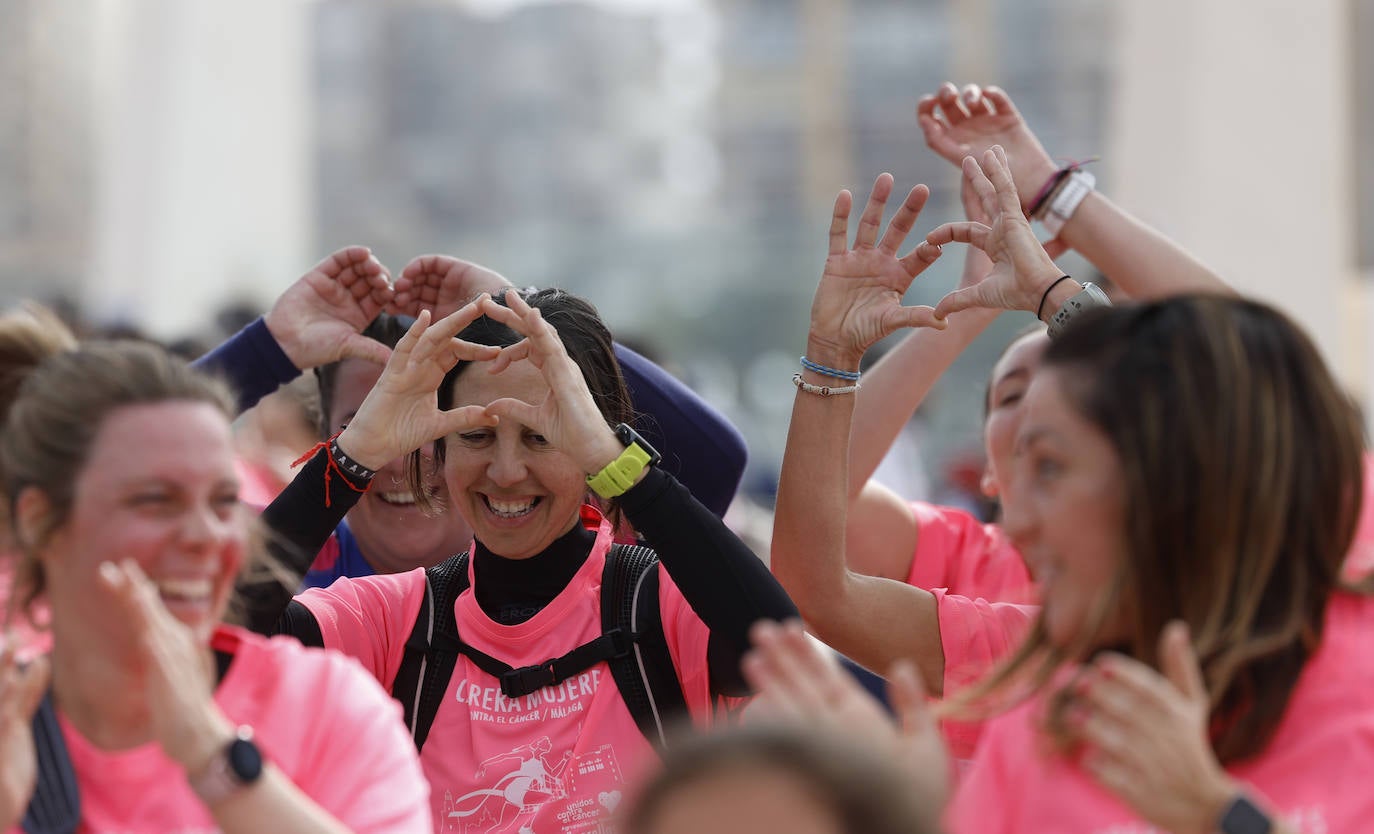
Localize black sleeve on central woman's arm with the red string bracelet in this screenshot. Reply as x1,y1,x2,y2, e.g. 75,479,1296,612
238,449,363,636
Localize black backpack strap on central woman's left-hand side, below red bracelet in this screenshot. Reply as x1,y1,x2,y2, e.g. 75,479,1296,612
392,551,469,750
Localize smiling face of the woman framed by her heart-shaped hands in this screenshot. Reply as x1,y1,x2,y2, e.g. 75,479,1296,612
444,361,587,559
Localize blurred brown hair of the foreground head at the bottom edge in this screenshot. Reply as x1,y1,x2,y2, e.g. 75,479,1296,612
625,724,938,834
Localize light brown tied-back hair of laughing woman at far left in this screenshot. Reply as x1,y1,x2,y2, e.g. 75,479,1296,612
0,311,234,607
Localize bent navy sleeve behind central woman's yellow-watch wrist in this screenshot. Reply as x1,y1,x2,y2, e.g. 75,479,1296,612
616,343,747,515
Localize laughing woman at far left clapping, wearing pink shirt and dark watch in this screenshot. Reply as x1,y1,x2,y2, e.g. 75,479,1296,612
0,321,430,834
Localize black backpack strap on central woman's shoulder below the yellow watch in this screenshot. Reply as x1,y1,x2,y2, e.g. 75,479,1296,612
602,544,687,749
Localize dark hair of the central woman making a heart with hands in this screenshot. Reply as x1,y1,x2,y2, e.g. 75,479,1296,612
408,290,635,525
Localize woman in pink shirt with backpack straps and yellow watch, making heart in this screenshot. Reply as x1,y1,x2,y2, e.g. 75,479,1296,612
254,290,796,834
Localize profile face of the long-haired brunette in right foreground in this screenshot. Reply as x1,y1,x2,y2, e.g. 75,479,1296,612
1002,368,1125,646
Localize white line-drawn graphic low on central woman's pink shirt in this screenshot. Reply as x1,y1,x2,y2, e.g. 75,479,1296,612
441,735,625,834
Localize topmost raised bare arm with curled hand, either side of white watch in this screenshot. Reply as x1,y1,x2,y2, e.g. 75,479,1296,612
916,82,1234,301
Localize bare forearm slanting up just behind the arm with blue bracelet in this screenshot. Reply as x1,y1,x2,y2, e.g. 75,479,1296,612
849,309,998,499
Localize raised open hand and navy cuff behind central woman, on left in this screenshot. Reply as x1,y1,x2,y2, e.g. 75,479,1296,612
194,246,392,411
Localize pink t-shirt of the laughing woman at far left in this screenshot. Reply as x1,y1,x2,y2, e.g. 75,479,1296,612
11,627,431,834
